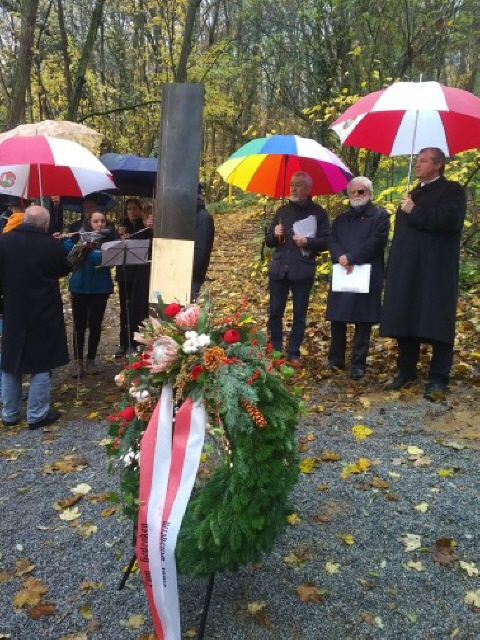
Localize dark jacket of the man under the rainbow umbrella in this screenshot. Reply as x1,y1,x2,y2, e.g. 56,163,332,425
265,198,330,282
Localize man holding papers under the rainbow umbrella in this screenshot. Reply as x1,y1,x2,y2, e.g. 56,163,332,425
265,171,330,369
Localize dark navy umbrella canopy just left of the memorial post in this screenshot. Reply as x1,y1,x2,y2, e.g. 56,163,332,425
100,153,158,198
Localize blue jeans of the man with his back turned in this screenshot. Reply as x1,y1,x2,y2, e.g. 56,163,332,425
2,371,51,424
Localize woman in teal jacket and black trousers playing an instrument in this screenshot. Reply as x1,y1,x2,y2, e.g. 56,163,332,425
65,211,114,378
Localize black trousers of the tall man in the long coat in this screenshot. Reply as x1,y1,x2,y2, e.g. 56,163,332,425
397,337,453,384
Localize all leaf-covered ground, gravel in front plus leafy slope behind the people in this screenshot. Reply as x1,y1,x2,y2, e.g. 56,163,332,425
0,212,480,640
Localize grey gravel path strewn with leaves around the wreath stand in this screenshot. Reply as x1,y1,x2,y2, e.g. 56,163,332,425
0,368,479,640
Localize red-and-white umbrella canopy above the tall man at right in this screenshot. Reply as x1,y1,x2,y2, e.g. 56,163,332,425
331,82,480,156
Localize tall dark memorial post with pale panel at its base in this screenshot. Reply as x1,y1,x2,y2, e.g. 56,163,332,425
149,83,204,305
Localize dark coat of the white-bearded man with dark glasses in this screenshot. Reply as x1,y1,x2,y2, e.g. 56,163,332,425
326,202,390,324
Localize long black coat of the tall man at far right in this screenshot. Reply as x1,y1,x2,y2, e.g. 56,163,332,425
380,176,466,344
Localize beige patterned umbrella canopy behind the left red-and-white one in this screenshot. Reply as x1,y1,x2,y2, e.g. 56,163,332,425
0,120,103,155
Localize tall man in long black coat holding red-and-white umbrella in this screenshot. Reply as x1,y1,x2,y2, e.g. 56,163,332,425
380,148,466,400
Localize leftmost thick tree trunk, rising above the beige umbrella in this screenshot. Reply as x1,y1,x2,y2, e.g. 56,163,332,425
6,0,39,129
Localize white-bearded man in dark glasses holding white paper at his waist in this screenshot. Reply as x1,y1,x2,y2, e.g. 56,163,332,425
326,176,390,380
